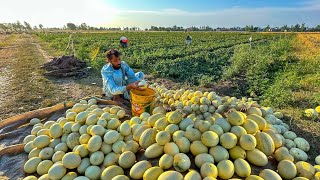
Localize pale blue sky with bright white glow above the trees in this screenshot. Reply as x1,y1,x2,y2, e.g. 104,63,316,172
0,0,320,28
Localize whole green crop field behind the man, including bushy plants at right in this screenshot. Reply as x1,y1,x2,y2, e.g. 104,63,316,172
38,32,320,107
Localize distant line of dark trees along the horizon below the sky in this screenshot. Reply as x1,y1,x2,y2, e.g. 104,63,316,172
0,21,320,33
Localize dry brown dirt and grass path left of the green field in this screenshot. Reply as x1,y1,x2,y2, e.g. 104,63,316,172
0,34,102,121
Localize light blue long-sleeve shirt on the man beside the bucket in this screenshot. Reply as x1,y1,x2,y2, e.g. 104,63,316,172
101,61,140,98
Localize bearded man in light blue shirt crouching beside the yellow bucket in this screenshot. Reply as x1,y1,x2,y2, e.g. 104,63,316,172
101,49,144,103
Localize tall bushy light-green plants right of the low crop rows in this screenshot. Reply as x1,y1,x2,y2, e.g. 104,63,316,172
224,38,294,96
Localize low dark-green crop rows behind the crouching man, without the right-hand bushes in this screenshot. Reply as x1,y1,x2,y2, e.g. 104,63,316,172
38,32,278,86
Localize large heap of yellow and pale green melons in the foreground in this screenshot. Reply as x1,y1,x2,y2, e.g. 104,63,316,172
24,84,320,180
